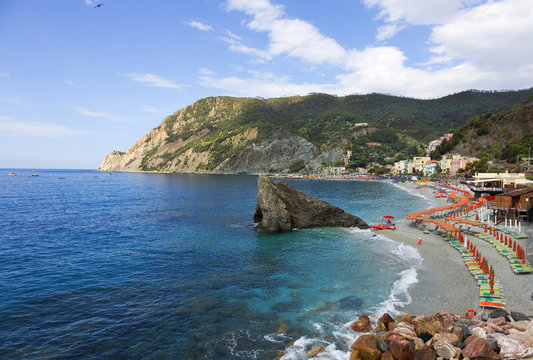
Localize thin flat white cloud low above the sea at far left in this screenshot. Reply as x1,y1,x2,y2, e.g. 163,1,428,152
0,116,84,137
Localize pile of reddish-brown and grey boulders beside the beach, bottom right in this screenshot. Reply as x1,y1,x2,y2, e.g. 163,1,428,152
344,311,533,360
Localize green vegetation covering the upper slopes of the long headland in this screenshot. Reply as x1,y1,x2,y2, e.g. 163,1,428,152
137,88,533,171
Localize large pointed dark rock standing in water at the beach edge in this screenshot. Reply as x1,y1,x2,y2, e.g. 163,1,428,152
254,175,369,233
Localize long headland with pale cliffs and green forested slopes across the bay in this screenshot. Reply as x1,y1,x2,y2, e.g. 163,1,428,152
100,88,533,173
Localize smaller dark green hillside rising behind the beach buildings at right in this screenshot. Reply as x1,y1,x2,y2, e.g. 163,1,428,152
431,96,533,172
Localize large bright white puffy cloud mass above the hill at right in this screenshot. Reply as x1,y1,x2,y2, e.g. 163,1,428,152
212,0,533,98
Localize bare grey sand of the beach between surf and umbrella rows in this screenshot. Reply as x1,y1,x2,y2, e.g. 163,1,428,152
382,185,533,315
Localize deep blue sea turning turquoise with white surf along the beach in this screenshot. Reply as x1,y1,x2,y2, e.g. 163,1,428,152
0,169,431,360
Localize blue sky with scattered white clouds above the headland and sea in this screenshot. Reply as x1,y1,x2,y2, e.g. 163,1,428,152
0,0,533,169
